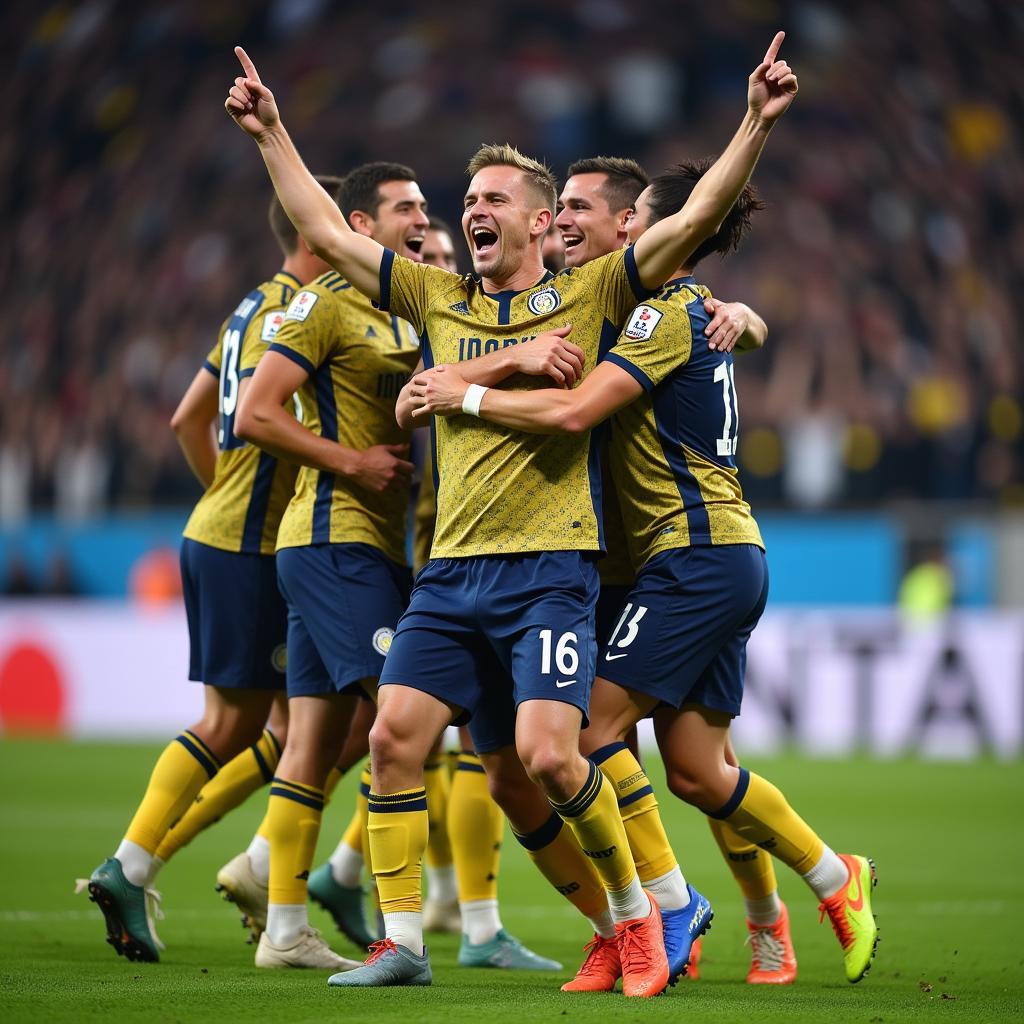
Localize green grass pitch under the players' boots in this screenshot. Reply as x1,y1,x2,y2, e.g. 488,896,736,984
0,740,1024,1024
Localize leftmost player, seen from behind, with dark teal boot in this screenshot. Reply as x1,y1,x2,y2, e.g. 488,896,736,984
79,178,340,961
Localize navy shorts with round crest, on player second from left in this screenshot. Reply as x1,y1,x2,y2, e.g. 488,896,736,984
278,544,412,697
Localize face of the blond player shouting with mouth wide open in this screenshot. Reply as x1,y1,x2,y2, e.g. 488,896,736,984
462,167,540,281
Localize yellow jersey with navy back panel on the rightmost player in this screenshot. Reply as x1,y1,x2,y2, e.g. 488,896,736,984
605,278,764,568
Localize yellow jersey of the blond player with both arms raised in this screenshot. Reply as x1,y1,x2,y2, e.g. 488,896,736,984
380,243,647,558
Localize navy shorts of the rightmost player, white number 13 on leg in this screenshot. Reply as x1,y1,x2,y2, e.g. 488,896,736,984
597,544,768,715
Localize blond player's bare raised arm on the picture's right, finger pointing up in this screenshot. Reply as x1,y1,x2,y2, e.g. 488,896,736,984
634,32,798,289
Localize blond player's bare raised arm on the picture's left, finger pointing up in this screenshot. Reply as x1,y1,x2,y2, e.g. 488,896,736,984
224,46,384,300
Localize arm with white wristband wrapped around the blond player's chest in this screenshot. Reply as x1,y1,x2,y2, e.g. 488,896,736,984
410,362,643,434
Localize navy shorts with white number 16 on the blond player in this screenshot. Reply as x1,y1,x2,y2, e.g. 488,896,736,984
380,551,598,754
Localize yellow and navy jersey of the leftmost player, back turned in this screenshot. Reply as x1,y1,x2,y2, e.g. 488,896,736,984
184,270,299,555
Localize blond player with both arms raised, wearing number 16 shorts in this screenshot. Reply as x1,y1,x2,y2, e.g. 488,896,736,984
225,33,796,995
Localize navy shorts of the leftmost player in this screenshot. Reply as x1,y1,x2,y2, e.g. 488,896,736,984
181,538,288,690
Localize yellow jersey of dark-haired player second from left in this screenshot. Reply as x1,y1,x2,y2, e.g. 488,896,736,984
270,272,420,565
